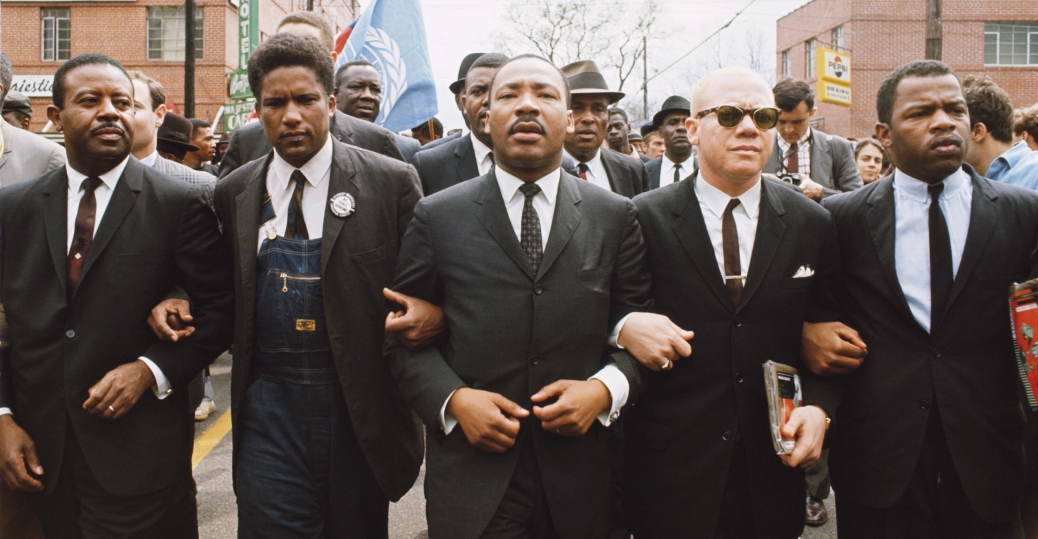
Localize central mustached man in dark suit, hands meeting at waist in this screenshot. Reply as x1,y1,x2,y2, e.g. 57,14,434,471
386,56,650,539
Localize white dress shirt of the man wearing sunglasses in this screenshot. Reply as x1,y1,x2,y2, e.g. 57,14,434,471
695,169,761,285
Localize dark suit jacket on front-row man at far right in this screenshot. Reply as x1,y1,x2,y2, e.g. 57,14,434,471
824,165,1038,521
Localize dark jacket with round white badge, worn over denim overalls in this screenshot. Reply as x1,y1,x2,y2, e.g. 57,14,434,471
216,141,425,501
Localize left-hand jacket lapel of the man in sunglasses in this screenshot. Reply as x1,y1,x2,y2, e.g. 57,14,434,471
674,178,735,313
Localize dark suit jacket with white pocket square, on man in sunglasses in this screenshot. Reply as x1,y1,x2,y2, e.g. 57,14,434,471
623,176,839,538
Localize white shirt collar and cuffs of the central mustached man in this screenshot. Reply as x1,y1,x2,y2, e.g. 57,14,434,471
440,168,630,434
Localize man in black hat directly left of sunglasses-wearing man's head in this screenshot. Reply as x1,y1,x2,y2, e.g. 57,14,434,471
646,96,699,189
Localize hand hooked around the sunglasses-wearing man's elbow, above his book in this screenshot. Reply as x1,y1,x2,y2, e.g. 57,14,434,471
800,322,869,376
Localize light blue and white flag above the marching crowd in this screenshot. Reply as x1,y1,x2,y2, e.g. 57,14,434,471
335,0,438,132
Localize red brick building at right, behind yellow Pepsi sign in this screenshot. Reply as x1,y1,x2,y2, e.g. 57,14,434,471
775,0,1038,137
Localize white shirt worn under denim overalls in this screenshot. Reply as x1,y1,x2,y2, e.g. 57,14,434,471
256,137,332,252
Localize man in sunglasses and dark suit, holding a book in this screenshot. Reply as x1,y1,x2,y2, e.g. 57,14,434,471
618,68,838,539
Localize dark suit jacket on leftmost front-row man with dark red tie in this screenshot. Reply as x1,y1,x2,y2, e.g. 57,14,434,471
0,157,234,496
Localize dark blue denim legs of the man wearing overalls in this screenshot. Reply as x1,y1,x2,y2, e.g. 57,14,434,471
235,370,389,539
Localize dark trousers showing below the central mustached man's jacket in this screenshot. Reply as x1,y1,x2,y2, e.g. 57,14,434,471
480,433,558,539
